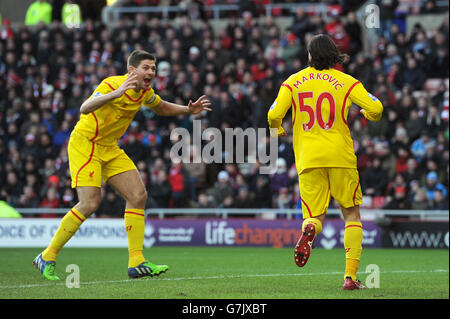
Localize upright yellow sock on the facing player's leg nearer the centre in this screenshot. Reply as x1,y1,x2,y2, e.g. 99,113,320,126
125,209,145,267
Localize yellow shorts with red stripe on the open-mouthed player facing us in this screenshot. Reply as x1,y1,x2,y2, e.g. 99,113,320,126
67,132,136,188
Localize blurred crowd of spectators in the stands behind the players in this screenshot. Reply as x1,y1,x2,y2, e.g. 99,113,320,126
0,1,449,217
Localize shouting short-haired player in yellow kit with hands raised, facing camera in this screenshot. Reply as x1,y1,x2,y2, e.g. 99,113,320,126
33,50,211,280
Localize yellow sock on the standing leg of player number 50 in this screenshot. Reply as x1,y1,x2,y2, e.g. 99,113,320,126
344,222,363,280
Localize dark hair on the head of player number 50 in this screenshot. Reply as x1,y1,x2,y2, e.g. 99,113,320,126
308,34,348,70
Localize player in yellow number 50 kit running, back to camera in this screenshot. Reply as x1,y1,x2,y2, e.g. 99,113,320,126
268,34,383,290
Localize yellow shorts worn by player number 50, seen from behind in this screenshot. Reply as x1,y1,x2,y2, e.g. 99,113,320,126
298,167,362,218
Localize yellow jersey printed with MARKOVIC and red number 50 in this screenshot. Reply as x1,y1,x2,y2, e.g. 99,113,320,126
268,67,383,174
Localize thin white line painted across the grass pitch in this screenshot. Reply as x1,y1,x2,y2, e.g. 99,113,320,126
0,269,448,289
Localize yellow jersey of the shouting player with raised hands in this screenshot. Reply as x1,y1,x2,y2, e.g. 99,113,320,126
74,74,161,145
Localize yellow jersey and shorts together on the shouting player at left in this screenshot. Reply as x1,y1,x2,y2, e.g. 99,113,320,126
68,74,161,188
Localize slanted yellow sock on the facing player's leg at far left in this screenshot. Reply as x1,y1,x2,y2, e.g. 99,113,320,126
42,208,86,261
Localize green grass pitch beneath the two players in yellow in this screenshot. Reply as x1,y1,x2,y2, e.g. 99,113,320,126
0,247,449,299
